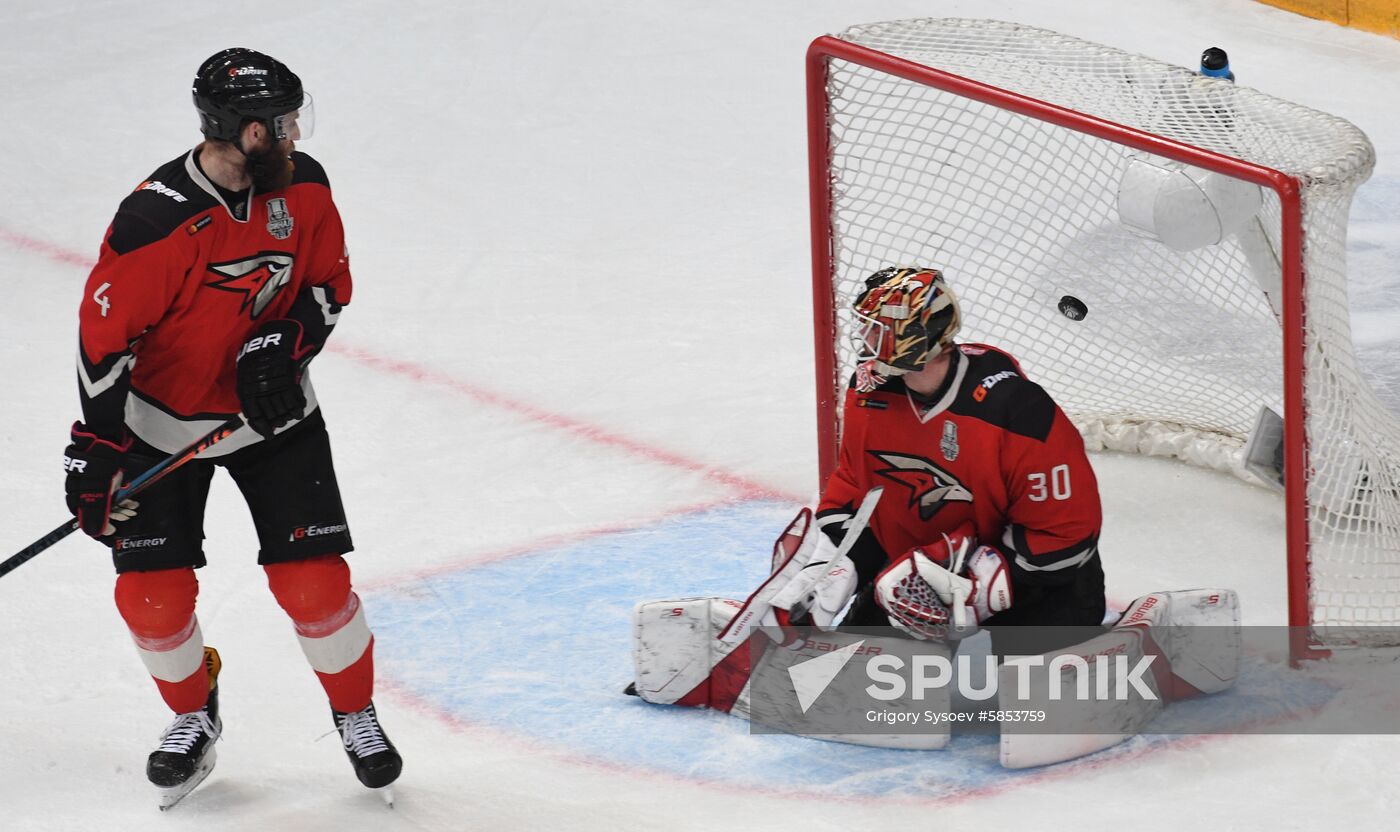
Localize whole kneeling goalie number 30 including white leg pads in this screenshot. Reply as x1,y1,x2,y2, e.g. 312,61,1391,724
626,268,1239,768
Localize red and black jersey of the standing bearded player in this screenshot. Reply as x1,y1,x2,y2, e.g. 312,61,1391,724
78,147,351,455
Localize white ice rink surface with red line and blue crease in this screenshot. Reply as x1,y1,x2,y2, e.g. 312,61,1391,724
0,0,1400,832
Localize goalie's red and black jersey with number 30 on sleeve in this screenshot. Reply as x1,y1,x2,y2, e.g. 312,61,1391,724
818,345,1103,585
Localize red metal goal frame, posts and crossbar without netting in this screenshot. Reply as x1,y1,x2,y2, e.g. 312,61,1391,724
806,35,1327,644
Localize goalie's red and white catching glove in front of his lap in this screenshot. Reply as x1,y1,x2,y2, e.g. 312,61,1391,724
875,524,1011,640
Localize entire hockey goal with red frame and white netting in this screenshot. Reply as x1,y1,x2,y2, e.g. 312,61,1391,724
808,20,1400,643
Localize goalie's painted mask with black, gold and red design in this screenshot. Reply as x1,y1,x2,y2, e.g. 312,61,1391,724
851,266,962,392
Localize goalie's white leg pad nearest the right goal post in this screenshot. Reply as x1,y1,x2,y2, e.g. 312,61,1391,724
997,590,1240,769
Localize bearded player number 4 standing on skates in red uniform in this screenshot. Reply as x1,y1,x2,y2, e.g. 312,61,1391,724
64,49,402,803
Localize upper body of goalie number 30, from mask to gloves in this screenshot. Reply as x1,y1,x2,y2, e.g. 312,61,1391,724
788,268,1105,654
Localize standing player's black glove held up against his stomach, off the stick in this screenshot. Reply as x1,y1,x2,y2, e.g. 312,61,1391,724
238,319,312,436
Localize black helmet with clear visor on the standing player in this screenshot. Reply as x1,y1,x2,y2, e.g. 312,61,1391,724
192,48,311,141
